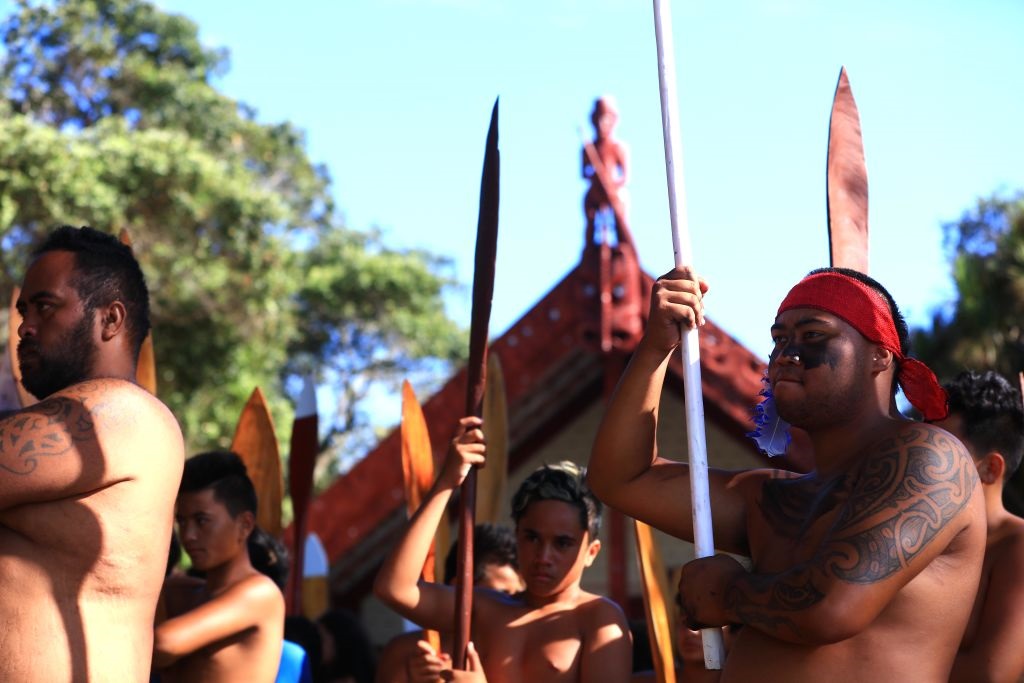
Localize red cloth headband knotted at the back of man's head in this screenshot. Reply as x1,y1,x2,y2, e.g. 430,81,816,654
778,272,949,422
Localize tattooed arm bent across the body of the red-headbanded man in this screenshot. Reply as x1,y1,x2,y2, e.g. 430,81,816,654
725,425,978,642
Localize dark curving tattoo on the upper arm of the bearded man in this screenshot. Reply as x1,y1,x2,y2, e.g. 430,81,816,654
0,382,102,475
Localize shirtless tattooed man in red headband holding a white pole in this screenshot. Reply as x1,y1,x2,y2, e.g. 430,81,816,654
589,268,985,683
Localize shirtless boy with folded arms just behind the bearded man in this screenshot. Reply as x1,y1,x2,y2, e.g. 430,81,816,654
153,451,285,683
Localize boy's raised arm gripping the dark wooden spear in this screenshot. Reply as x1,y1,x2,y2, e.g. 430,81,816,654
374,417,485,631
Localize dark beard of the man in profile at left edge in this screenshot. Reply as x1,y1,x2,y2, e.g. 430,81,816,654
17,311,96,400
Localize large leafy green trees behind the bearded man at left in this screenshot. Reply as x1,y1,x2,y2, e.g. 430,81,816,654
0,0,465,475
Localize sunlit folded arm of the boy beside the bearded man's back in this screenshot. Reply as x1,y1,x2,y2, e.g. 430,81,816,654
153,574,285,669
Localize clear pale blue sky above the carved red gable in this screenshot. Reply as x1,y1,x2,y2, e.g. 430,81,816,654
18,0,1024,355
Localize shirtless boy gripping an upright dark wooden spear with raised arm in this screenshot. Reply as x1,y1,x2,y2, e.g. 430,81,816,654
374,417,633,683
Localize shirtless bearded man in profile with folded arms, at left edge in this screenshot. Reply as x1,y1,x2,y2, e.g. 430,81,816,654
0,226,184,681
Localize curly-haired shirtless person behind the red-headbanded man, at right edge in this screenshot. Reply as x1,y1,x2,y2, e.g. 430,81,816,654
938,372,1024,683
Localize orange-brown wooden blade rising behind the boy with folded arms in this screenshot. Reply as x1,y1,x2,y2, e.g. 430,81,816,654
231,387,284,538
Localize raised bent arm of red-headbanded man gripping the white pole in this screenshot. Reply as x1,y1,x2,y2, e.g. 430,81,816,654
587,270,749,554
